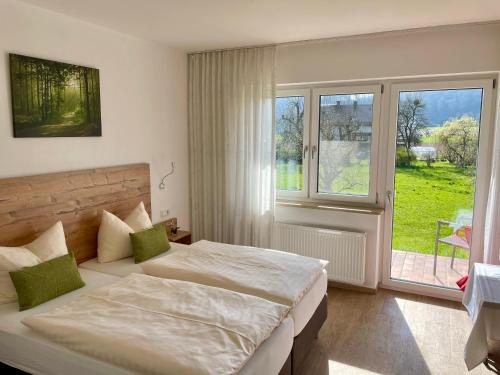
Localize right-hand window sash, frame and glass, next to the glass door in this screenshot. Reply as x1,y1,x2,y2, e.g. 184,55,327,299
310,86,380,203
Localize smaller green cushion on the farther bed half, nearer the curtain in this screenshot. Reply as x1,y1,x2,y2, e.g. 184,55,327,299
129,224,170,263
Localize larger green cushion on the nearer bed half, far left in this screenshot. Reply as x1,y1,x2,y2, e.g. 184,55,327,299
10,252,85,311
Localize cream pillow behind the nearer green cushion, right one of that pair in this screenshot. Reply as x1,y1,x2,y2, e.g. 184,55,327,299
23,221,68,262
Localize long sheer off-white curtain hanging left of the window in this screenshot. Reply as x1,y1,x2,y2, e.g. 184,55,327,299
189,47,275,247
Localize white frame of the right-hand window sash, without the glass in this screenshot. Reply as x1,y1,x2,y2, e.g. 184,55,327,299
309,84,382,204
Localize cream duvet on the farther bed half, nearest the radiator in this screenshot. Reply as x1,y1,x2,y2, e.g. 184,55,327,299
142,241,328,307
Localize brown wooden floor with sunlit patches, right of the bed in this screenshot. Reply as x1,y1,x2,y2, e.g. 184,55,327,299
299,288,492,375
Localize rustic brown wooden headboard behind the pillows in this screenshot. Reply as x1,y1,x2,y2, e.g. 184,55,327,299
0,164,151,263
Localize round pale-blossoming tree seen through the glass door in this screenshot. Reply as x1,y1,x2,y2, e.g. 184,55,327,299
437,115,479,168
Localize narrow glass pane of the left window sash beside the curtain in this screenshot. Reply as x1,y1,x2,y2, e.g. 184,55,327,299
275,96,304,191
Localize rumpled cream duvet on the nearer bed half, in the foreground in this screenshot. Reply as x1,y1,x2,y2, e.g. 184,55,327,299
22,274,289,375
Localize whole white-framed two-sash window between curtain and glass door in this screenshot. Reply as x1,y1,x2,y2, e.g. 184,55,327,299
276,85,381,203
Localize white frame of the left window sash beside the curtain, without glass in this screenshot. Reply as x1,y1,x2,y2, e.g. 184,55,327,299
274,88,311,200
